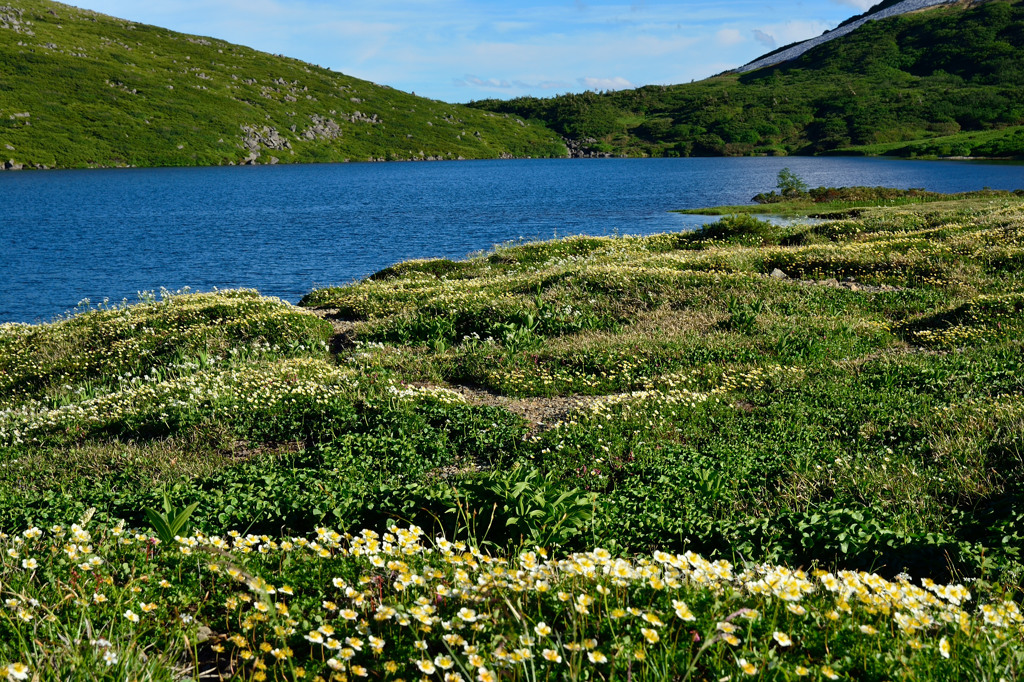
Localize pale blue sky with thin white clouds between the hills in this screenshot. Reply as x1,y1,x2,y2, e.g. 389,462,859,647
74,0,874,102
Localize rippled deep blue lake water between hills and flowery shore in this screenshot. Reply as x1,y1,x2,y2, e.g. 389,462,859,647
0,158,1024,322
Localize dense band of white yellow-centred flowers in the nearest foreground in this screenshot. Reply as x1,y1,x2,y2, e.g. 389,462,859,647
0,521,1024,680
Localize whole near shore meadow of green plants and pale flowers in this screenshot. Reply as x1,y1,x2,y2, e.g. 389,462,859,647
0,195,1024,681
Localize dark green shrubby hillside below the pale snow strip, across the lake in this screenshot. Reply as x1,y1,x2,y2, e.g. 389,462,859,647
472,1,1024,156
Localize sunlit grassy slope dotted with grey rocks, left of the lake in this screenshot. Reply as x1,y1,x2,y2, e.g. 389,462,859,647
0,0,565,168
